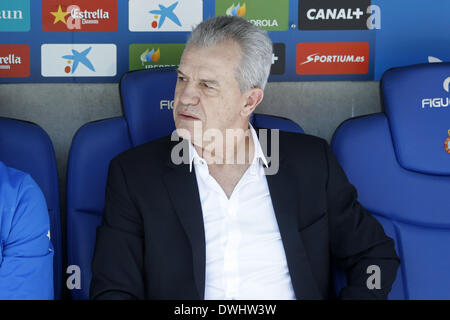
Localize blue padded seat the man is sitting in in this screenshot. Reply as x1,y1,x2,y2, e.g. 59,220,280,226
67,68,303,299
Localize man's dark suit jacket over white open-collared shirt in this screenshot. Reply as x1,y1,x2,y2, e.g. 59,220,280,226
90,131,400,299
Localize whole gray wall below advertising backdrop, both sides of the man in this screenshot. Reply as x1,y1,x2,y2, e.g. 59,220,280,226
0,81,381,194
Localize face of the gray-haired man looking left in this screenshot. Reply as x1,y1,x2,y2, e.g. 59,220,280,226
173,41,246,143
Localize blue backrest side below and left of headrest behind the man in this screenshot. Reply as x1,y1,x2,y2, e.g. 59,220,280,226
66,117,132,300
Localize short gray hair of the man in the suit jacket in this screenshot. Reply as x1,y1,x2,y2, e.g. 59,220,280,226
186,16,272,93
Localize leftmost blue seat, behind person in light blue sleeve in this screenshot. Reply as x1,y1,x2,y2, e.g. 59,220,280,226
0,117,62,299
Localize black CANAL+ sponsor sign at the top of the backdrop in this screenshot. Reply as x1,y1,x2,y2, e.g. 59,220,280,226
298,0,381,30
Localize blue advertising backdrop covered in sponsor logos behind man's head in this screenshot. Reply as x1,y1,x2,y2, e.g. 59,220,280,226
0,0,450,83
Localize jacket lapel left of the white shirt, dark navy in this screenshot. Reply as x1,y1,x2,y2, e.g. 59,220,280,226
164,140,206,299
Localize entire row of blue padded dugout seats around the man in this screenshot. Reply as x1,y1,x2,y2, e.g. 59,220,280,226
0,63,450,299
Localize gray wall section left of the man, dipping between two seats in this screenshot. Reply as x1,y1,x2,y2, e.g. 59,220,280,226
0,84,121,186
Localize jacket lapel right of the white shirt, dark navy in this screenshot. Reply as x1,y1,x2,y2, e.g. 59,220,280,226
257,130,323,299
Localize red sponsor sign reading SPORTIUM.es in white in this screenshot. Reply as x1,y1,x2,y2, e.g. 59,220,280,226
296,42,369,75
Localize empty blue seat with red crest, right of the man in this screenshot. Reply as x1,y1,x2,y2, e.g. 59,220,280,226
332,63,450,299
